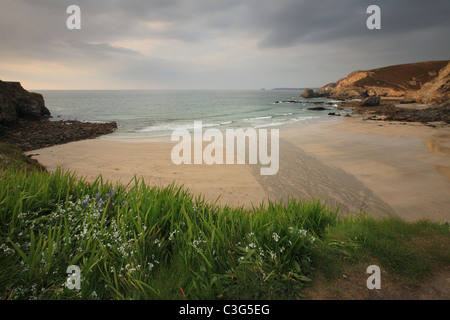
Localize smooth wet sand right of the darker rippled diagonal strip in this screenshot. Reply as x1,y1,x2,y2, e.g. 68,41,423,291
285,118,450,221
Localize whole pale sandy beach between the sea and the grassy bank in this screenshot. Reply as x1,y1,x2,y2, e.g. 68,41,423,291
28,117,450,221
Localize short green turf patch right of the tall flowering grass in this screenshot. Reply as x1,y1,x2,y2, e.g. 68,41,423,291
313,216,450,287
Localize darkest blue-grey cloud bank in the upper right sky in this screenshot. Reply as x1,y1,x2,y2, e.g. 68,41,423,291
244,0,450,47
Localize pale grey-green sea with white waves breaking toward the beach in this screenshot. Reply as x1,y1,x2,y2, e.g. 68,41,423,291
39,89,346,139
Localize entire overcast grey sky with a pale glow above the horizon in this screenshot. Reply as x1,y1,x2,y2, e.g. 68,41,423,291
0,0,450,90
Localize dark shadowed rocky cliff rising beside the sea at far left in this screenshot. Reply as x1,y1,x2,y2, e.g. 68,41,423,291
0,80,50,123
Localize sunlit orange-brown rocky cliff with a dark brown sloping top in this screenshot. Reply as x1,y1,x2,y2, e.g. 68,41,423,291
309,60,450,104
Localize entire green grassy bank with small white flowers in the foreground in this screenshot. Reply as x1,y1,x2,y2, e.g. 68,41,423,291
0,144,450,299
